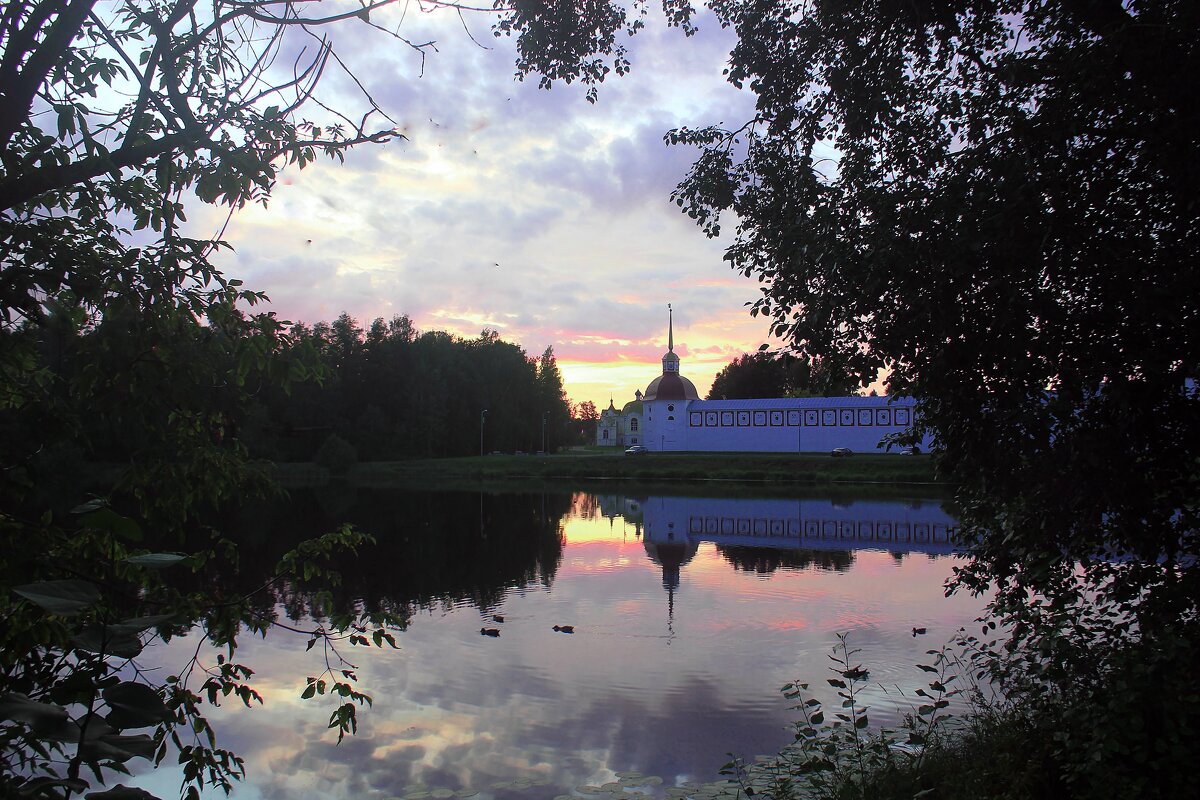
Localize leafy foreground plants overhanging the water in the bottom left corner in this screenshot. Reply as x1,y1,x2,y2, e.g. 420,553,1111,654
0,501,397,799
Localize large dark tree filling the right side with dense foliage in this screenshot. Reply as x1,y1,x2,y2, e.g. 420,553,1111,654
667,0,1200,796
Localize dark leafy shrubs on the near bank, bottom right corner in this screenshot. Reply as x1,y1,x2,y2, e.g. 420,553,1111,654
724,618,1200,800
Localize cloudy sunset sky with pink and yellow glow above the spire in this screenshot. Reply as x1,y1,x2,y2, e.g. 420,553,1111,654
192,4,767,407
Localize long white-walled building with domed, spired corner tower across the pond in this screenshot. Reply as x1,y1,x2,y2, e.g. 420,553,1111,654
596,313,929,452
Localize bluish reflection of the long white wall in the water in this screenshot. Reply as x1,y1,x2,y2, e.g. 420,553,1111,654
643,497,958,553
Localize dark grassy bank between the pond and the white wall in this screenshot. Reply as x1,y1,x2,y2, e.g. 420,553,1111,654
276,450,940,489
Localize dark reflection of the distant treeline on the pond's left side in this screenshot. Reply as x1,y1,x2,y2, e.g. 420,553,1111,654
226,485,571,620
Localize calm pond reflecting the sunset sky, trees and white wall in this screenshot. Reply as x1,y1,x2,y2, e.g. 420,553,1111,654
126,488,984,800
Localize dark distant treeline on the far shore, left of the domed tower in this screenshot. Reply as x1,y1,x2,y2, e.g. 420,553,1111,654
239,313,576,462
